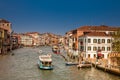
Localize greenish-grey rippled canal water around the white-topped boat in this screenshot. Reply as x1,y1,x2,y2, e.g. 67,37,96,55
0,47,120,80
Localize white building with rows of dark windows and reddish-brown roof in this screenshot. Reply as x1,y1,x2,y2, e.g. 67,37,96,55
78,32,112,59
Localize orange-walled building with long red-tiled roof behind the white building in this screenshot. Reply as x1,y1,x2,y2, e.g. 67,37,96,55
66,25,118,49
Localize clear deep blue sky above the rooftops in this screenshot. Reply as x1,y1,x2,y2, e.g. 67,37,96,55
0,0,120,35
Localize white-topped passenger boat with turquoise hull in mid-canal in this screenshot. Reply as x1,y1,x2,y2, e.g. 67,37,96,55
38,54,53,70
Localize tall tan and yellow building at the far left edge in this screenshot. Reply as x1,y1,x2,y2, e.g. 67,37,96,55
0,19,12,53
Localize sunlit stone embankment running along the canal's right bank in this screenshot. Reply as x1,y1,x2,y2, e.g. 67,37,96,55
64,48,120,76
